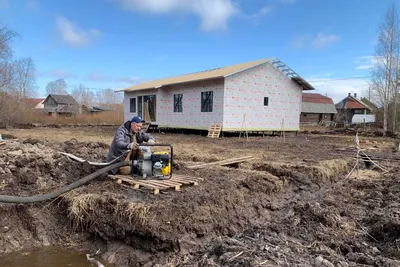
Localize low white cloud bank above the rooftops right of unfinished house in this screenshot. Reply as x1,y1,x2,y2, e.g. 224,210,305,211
306,78,368,104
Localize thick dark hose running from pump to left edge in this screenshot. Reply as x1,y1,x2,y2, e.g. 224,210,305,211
0,161,129,203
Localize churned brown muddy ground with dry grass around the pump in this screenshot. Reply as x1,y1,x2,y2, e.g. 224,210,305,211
0,127,400,267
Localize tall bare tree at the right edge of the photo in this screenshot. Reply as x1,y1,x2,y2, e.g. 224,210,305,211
371,3,400,133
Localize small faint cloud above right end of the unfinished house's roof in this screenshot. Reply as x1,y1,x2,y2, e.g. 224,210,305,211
292,33,340,49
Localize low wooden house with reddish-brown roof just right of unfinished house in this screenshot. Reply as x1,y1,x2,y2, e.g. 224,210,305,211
300,93,337,124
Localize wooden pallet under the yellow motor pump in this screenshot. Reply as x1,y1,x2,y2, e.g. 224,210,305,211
108,174,203,195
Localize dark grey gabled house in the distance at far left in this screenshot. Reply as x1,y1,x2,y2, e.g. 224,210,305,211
43,94,80,115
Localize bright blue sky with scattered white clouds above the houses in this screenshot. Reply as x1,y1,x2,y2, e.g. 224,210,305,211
0,0,394,103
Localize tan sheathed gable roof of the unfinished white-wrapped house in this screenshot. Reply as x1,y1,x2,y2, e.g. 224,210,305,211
117,58,314,92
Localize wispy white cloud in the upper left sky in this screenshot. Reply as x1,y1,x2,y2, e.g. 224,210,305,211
56,16,101,47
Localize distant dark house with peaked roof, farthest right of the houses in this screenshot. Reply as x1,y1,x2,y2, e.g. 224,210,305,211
335,93,375,124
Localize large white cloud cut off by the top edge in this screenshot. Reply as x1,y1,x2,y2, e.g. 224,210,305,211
115,0,239,31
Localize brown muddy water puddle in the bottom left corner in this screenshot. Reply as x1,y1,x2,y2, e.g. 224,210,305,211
0,247,109,267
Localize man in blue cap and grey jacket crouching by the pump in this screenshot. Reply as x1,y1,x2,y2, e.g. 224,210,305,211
107,116,155,174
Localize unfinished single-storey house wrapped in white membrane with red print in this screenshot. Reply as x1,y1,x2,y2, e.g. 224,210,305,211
120,58,314,132
